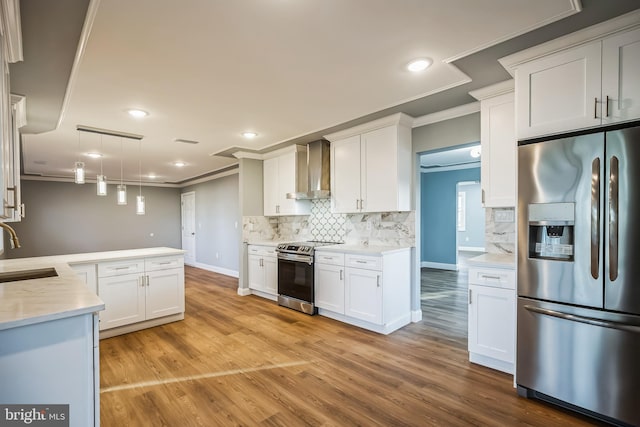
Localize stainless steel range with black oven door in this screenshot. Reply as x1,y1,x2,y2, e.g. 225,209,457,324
276,241,336,315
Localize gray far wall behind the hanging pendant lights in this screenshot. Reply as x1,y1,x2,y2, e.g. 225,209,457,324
4,180,182,258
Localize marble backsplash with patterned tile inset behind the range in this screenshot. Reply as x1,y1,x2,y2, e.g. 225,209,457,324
242,199,415,246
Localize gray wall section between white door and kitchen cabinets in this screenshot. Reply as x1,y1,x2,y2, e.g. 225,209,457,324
182,174,242,272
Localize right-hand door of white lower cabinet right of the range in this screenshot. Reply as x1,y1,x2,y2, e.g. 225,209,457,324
345,268,382,324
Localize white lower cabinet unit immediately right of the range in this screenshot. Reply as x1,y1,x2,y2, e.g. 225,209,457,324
314,248,411,334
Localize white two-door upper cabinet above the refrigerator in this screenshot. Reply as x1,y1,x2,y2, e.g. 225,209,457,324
500,11,640,139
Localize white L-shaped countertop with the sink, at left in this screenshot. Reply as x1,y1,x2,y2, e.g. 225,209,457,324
0,248,184,330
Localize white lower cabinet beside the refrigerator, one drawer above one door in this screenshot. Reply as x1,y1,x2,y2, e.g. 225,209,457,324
468,267,516,374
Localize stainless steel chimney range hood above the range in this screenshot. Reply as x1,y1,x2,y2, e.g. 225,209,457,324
287,139,331,200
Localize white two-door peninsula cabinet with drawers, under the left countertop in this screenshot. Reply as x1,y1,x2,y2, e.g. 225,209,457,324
98,256,184,336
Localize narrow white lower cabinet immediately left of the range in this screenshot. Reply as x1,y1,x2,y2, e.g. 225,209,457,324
247,245,278,299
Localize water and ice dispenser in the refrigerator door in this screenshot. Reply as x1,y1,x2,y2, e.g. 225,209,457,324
529,203,575,261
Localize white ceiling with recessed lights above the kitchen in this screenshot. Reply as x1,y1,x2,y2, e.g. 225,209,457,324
16,0,577,183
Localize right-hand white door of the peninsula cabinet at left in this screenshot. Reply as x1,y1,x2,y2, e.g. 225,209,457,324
145,268,184,320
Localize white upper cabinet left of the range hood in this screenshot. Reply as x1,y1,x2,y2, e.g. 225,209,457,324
262,145,311,216
